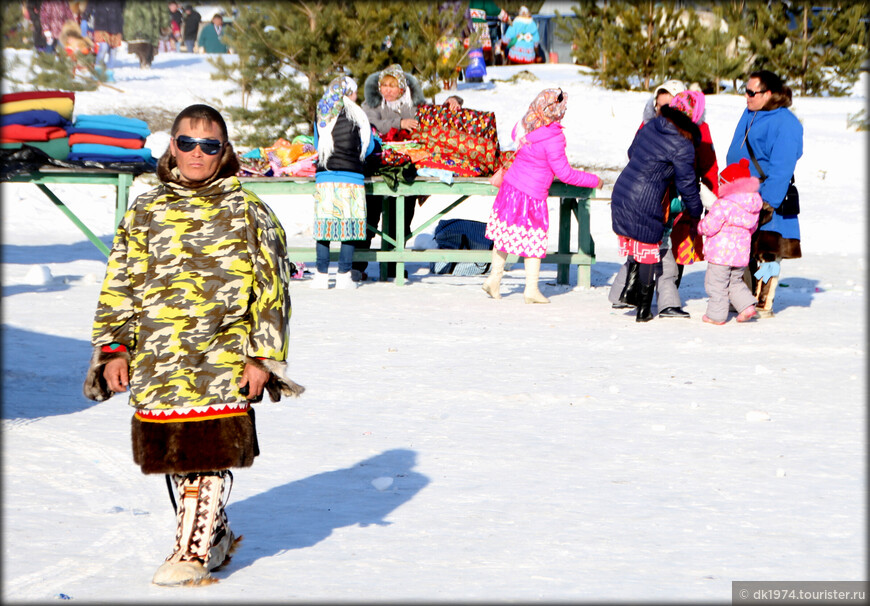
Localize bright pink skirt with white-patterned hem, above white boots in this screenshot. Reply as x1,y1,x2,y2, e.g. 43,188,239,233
486,182,550,259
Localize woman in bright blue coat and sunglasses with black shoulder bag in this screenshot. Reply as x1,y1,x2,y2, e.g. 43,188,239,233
727,70,804,318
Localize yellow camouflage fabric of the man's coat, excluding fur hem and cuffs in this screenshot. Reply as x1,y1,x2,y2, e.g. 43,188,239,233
92,177,290,409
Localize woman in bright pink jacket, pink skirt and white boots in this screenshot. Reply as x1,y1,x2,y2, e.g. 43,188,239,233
483,88,602,303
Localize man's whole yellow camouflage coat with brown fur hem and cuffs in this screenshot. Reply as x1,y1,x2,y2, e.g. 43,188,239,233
83,169,304,473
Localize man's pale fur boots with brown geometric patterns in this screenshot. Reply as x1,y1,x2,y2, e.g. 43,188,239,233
151,470,241,585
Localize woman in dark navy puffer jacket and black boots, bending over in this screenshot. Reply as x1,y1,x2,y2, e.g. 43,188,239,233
610,93,704,322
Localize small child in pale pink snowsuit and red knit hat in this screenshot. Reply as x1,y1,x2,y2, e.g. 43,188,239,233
698,158,762,324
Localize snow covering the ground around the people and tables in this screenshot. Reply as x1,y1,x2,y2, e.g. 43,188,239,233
2,51,867,603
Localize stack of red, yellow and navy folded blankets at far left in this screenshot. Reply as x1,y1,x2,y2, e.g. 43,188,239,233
0,91,75,160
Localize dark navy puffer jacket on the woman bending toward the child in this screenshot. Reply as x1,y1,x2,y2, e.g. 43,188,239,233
610,105,703,244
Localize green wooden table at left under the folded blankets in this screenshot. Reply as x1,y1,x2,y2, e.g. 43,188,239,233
6,166,133,257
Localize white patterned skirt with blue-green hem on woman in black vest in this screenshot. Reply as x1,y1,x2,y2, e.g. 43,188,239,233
314,183,366,242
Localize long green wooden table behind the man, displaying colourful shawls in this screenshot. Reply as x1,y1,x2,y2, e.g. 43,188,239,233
240,177,595,288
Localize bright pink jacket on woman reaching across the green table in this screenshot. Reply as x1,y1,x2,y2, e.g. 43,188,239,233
504,122,598,200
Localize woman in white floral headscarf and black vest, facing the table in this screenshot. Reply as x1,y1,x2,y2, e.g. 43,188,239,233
311,76,375,289
